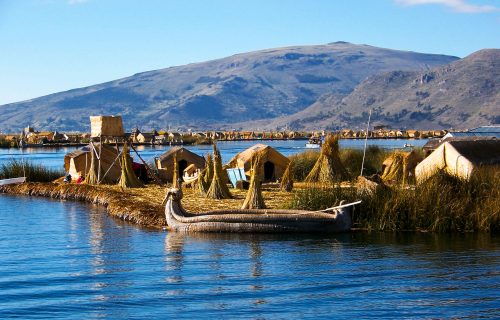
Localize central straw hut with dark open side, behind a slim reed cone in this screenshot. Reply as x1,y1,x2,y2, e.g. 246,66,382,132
227,143,290,181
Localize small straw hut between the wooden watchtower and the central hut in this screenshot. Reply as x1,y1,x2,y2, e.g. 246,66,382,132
155,147,205,182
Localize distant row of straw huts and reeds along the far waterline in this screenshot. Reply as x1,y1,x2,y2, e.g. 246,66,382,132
0,126,454,148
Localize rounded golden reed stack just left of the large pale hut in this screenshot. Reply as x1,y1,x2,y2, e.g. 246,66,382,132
381,151,422,184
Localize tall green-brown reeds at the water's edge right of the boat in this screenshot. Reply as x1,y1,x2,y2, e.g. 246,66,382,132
288,168,500,232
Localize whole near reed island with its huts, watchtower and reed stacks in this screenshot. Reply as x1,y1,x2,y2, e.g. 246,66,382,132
0,116,500,232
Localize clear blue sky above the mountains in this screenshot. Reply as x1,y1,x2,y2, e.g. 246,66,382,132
0,0,500,104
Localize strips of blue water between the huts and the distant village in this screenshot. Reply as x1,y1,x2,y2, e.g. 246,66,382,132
0,139,427,169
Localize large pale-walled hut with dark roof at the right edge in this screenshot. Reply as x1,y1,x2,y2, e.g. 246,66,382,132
415,138,500,183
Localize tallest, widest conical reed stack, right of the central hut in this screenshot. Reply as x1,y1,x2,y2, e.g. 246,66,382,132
305,134,349,183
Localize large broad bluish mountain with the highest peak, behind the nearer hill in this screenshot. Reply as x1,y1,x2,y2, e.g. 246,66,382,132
0,42,458,131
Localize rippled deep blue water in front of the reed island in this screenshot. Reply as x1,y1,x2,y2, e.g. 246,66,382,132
0,195,500,319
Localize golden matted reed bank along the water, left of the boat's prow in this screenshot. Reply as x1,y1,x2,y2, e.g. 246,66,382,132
0,182,166,230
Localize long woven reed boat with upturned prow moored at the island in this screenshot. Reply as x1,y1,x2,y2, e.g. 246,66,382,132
165,188,361,233
